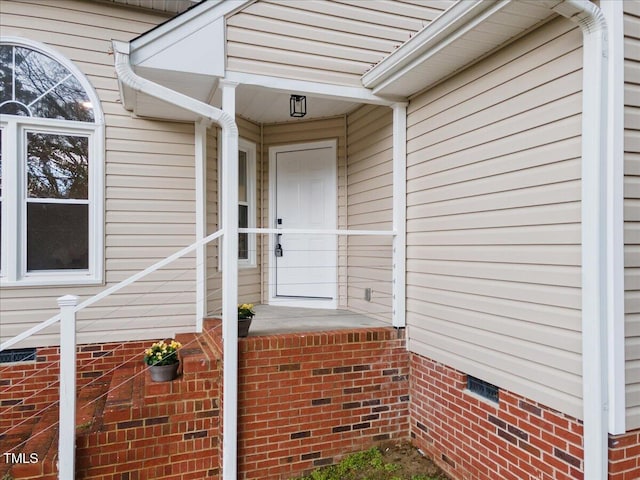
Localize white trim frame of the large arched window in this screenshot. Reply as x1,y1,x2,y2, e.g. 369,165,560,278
0,37,105,287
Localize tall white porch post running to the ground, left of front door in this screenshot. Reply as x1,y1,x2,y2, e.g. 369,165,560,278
220,80,238,480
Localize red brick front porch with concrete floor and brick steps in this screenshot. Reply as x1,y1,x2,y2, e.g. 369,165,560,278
0,316,409,480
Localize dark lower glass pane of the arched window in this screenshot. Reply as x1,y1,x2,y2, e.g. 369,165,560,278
27,203,89,271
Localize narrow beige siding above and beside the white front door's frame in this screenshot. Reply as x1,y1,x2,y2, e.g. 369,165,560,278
261,116,347,307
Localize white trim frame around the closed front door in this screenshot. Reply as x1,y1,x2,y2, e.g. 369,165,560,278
268,139,338,309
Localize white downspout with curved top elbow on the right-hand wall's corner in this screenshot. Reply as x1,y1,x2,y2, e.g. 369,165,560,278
547,0,609,480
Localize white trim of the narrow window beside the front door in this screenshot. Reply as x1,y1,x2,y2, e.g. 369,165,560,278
218,138,258,271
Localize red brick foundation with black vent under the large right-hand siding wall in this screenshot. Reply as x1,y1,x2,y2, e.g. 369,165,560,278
411,354,583,480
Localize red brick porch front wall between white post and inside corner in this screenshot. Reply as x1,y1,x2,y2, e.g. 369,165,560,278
238,328,409,480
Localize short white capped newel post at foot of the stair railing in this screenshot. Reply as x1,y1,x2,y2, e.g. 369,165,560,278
58,295,78,480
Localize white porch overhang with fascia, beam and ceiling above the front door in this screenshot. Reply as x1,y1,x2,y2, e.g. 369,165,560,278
112,0,406,123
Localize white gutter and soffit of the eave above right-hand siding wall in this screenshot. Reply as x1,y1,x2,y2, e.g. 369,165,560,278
362,0,555,96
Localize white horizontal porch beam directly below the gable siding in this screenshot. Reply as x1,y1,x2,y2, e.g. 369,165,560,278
225,70,406,107
